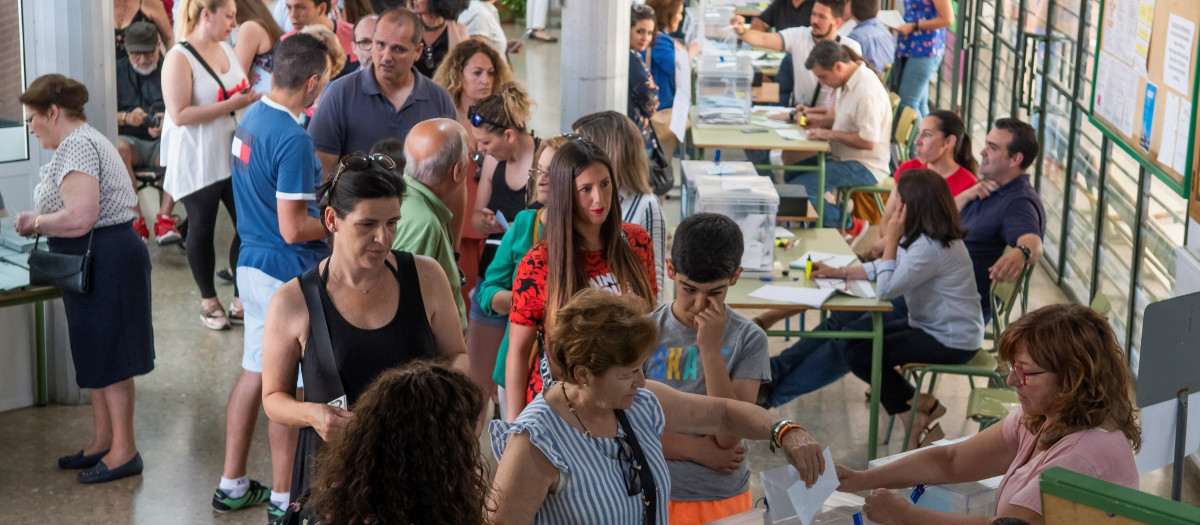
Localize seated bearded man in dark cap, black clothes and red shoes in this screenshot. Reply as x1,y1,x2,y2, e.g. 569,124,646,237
116,22,182,246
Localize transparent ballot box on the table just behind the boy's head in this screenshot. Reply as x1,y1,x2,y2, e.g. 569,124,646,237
688,163,779,274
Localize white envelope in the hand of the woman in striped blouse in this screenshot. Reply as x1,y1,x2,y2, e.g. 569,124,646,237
760,447,840,525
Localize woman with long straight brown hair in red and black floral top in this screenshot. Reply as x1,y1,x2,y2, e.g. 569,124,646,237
505,137,658,422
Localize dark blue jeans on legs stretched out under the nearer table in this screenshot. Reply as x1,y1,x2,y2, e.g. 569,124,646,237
770,297,908,406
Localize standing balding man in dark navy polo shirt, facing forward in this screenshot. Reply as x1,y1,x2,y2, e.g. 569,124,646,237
308,7,458,177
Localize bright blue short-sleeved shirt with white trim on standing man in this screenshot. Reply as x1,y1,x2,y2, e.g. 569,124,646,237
229,96,330,282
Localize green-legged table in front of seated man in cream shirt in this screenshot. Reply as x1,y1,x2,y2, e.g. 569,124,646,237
688,107,829,221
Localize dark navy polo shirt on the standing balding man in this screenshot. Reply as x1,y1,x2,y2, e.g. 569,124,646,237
308,65,458,157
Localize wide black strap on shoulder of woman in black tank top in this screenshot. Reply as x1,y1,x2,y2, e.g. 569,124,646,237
300,263,346,403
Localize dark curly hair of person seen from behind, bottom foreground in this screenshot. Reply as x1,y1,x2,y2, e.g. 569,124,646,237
306,361,488,525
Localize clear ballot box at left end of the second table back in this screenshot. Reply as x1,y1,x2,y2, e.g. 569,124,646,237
694,54,754,127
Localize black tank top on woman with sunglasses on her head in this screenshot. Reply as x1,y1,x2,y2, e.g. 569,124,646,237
302,251,437,410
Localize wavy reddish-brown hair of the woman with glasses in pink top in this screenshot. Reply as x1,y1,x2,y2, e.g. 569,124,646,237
993,305,1141,451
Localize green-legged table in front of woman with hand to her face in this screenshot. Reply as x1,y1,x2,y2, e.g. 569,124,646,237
725,228,892,460
